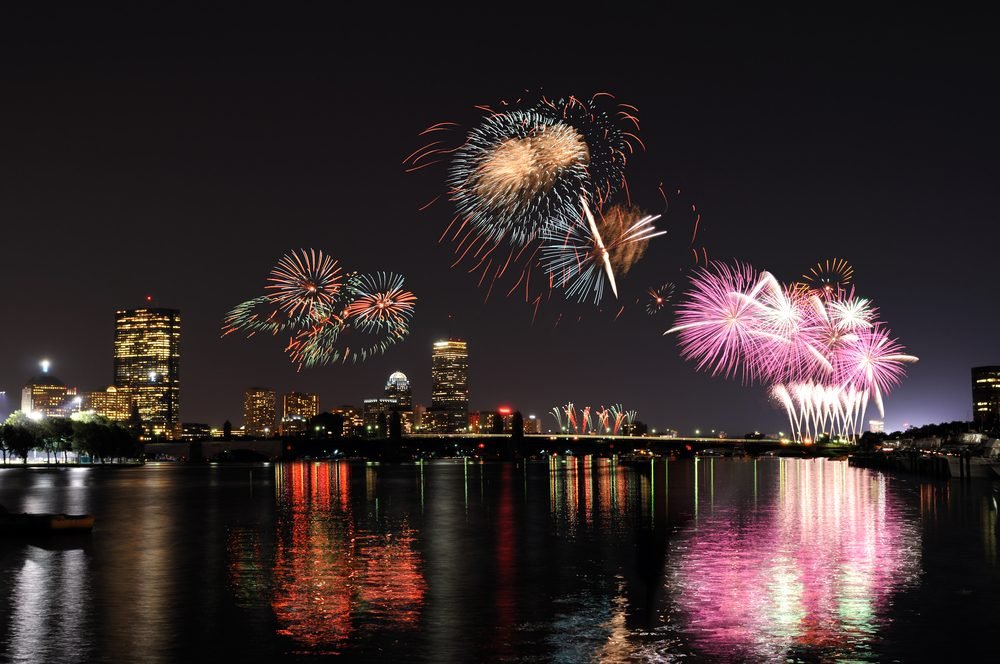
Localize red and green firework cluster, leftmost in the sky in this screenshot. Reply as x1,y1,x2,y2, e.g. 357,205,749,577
222,249,417,369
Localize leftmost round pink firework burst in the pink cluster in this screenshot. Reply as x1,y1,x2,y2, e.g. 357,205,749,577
664,262,769,382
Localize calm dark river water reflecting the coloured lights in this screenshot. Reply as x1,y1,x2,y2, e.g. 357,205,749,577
0,458,1000,662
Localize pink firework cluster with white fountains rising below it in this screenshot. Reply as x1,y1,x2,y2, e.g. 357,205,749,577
665,263,917,440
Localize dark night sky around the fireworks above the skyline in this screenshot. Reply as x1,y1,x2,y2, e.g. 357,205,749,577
0,3,1000,433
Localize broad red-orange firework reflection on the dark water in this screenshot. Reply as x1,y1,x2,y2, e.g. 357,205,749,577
262,463,426,653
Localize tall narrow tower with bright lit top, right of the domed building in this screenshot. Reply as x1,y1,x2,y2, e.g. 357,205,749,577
427,339,469,433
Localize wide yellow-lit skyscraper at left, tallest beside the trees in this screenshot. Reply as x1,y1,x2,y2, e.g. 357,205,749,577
114,308,181,439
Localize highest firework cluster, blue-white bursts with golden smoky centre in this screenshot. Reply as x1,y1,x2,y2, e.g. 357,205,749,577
404,93,704,319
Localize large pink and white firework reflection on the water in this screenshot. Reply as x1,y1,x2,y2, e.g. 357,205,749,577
669,459,921,661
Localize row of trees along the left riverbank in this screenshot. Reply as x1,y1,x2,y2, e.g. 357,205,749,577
0,410,143,463
